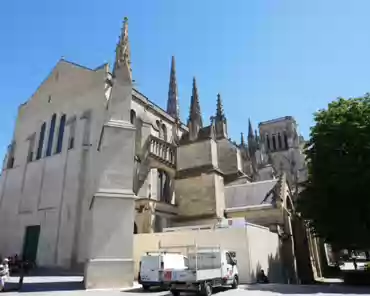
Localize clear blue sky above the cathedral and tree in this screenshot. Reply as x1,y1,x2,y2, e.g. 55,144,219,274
0,0,370,157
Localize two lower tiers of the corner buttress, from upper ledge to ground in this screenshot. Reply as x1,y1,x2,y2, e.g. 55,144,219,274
84,121,135,289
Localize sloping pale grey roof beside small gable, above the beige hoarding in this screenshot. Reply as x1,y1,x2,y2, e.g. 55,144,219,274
225,179,279,208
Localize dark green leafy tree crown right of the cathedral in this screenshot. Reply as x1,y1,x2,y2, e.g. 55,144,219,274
297,94,370,248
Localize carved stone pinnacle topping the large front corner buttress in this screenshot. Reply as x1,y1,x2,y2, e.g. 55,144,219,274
113,17,132,80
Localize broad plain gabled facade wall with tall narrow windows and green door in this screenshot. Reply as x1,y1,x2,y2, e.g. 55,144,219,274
0,61,106,267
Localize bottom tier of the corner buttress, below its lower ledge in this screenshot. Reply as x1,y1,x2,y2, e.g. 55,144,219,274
85,192,135,289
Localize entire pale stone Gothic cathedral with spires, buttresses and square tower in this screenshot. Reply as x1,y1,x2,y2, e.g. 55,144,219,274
0,19,306,286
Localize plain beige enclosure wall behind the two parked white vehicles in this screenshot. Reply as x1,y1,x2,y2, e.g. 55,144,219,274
134,224,283,283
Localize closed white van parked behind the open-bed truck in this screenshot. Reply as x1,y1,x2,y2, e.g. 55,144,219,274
138,252,188,290
